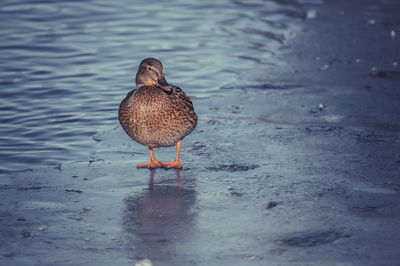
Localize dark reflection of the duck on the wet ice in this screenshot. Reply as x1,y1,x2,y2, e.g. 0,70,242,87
124,170,196,261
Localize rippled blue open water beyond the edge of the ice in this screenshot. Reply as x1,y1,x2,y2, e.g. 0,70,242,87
0,0,319,173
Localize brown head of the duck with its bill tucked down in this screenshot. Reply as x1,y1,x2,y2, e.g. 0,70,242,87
136,58,172,91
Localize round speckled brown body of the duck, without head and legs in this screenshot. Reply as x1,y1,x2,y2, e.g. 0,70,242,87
119,86,197,148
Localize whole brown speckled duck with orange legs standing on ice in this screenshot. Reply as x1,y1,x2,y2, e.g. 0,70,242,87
118,58,197,168
